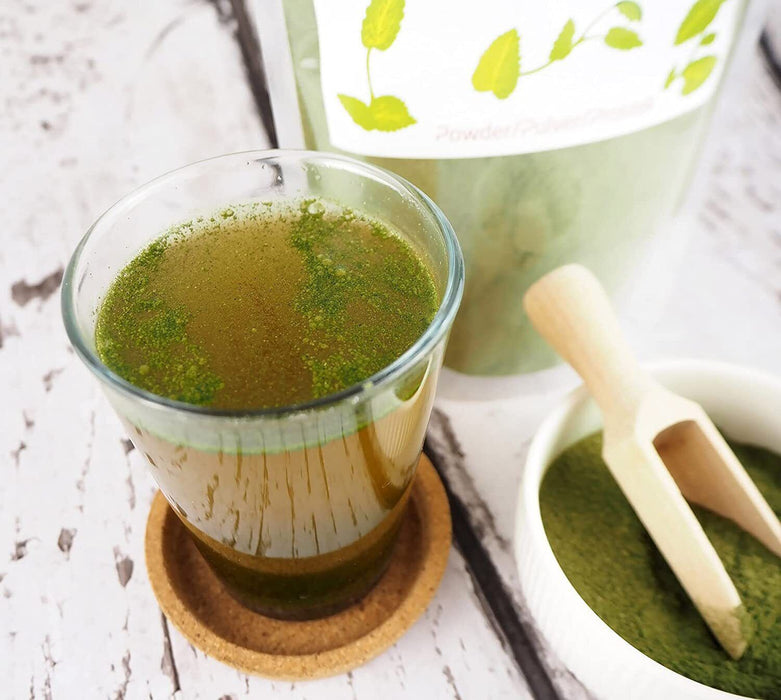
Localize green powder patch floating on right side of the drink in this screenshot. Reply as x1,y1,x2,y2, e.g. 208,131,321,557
291,200,438,397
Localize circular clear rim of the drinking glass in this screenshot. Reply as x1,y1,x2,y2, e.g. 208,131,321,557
60,149,464,419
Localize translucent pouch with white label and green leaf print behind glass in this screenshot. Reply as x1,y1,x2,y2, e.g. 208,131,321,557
256,0,757,375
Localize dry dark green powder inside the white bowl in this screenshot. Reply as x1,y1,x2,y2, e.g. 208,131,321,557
540,434,781,700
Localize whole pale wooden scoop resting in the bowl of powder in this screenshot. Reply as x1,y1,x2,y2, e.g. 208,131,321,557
523,265,781,659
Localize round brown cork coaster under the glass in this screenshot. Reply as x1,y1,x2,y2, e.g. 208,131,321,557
145,455,451,681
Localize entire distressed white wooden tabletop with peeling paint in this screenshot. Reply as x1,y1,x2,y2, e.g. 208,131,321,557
0,0,781,700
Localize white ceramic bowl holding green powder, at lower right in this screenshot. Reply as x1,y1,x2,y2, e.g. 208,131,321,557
515,360,781,700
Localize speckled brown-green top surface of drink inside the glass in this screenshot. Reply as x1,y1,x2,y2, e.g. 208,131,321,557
95,199,439,409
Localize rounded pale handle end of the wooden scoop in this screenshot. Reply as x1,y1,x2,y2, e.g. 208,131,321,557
523,264,653,420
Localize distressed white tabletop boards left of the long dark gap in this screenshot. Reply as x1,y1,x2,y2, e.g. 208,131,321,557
0,0,528,700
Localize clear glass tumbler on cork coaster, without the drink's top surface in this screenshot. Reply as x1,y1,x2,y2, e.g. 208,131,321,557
62,151,464,619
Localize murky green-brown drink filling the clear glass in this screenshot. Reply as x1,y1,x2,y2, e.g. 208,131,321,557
95,200,440,617
